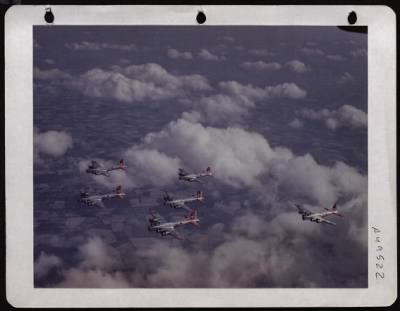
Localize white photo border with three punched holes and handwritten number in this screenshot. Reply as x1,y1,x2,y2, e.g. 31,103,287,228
5,5,397,307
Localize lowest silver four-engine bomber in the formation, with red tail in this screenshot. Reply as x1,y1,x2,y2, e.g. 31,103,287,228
147,210,200,240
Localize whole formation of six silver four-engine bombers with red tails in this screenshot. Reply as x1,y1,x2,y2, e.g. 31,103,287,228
79,159,343,240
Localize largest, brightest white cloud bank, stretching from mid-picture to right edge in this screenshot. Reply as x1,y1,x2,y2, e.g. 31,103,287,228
104,118,366,204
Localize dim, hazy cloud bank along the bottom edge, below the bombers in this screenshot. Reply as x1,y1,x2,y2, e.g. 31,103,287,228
45,188,367,288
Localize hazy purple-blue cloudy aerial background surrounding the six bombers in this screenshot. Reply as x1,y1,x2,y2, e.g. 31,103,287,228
33,26,368,288
